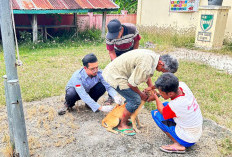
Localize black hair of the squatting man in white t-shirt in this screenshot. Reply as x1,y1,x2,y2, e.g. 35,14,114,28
155,72,179,93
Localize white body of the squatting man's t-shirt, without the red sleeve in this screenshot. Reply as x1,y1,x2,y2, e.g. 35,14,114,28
164,82,203,143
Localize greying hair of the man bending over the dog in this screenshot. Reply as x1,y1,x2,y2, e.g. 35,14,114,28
160,54,179,73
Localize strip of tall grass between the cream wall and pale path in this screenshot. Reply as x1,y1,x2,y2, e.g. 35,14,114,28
139,26,232,56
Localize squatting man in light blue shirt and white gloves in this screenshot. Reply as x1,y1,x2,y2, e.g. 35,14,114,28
58,53,121,115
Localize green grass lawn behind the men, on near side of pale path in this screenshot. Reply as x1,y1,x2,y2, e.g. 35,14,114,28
0,42,232,129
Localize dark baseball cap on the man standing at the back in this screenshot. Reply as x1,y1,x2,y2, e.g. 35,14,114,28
106,19,122,39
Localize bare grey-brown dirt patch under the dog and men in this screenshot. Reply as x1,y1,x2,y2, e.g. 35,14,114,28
0,95,232,157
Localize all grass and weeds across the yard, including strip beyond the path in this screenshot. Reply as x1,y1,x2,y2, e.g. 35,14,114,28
0,29,232,155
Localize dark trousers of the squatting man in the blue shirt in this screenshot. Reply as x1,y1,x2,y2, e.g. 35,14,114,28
65,82,106,107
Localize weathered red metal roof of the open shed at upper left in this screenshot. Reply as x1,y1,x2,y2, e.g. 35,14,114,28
12,0,118,10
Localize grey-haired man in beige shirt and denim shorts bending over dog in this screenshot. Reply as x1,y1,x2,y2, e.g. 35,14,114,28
102,49,178,135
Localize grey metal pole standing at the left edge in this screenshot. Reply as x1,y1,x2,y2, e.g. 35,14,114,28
0,0,30,157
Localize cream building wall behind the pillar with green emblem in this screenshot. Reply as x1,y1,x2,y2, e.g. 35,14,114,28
137,0,232,38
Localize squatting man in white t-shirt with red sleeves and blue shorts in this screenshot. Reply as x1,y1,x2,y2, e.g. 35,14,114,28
150,73,203,153
